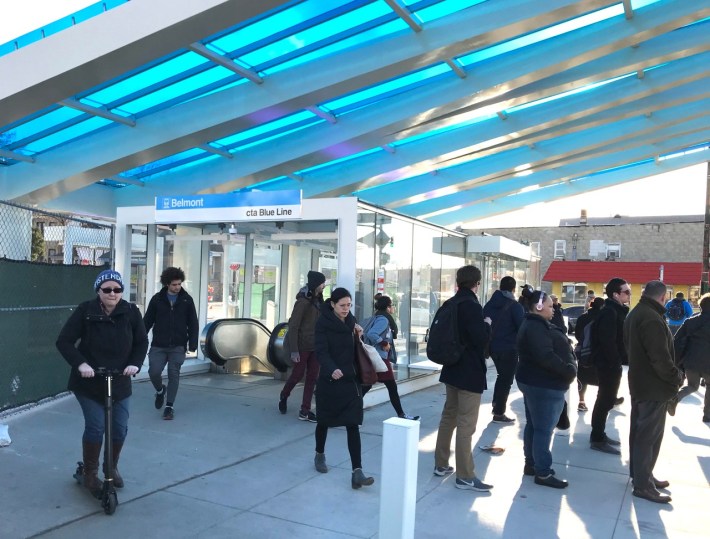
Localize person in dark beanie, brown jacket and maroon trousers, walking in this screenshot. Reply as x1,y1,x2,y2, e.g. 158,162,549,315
279,271,325,423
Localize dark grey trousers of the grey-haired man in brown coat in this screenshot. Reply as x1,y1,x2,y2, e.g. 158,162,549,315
629,399,668,489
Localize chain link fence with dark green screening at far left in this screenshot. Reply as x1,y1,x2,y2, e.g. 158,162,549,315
0,201,114,412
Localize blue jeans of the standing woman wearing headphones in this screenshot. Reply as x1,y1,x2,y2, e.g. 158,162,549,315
518,382,565,477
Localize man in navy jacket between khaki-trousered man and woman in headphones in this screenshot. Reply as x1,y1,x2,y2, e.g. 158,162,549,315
483,276,525,424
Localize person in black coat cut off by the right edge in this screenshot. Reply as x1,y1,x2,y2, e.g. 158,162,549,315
669,293,710,423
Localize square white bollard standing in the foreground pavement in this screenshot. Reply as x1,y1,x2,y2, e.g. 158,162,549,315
379,417,419,539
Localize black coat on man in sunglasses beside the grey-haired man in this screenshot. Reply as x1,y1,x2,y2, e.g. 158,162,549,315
592,298,629,371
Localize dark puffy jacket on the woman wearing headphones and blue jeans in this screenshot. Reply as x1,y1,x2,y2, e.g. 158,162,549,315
515,313,577,391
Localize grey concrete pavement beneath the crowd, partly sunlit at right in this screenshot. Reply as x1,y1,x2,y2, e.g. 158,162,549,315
0,369,710,539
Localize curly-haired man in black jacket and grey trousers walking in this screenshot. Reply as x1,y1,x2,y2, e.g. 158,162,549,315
143,267,199,419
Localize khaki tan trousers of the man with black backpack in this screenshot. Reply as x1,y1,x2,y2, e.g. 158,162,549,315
434,384,481,480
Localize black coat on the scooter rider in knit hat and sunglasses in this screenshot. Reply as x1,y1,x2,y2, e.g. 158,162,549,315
56,298,148,403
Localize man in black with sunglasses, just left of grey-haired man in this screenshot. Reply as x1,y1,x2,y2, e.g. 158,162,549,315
589,277,631,455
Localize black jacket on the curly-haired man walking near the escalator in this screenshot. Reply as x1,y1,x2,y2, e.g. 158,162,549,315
143,286,200,352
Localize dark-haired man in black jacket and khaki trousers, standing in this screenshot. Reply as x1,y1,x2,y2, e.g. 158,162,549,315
434,266,493,492
